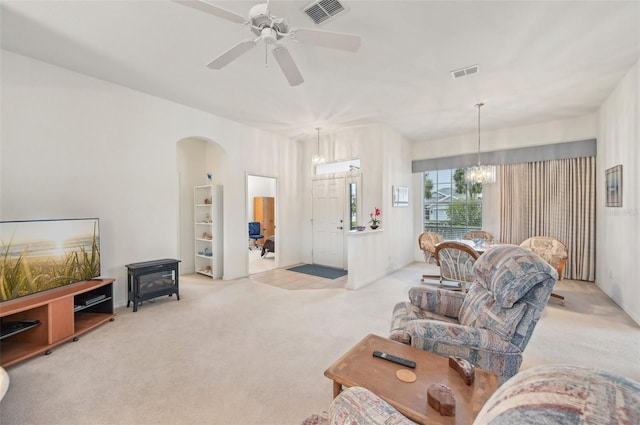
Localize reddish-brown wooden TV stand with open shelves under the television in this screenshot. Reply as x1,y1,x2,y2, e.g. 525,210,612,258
0,279,115,367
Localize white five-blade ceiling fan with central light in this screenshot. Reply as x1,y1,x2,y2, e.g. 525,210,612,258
173,0,360,86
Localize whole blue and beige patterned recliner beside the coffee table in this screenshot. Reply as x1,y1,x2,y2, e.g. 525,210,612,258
390,245,558,384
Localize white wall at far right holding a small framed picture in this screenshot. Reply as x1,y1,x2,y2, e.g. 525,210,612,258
596,62,640,323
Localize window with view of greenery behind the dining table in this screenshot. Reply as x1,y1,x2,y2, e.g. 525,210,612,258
424,168,482,239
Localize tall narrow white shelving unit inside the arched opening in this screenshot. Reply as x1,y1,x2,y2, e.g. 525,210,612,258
193,185,223,279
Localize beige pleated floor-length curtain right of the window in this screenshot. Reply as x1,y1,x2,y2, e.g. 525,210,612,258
498,157,596,281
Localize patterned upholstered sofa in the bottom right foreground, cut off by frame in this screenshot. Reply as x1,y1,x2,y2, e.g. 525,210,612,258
303,365,640,425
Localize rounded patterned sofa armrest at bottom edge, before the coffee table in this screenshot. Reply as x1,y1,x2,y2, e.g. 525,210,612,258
329,387,416,425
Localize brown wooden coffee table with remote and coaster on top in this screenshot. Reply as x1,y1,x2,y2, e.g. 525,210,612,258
324,335,498,425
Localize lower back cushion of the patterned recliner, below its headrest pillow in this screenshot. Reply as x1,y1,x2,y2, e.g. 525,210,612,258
459,285,527,341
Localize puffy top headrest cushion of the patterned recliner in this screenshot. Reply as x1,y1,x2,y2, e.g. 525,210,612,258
474,245,558,308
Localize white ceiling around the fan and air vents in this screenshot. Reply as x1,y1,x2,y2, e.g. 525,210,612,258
0,0,640,140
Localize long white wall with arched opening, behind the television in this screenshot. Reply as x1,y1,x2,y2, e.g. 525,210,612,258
0,51,303,305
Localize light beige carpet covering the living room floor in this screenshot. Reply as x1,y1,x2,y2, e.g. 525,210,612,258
0,263,640,425
